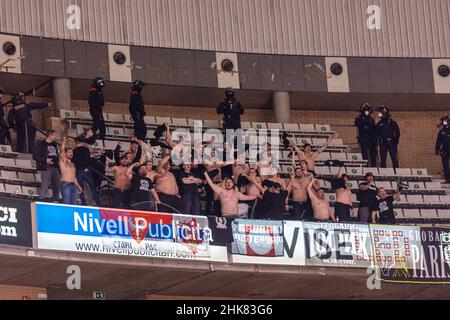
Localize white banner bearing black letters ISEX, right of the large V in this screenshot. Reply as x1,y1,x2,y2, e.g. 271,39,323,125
303,222,373,268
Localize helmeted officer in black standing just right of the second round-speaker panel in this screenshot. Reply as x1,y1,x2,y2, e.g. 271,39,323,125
129,80,147,141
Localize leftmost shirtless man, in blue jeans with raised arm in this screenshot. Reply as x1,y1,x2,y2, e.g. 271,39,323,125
59,137,83,205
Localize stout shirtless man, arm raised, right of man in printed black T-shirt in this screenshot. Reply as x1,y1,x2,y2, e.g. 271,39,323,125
155,155,184,213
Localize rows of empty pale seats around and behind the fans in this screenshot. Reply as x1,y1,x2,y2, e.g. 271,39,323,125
0,110,450,224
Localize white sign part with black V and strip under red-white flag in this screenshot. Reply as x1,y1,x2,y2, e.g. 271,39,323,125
232,221,305,266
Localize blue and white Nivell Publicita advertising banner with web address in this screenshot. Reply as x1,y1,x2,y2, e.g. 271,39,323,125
36,203,227,262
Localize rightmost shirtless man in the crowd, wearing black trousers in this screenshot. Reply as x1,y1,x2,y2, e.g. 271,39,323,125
332,167,353,222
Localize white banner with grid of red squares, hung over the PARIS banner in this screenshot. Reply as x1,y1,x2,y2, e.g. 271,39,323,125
370,225,422,279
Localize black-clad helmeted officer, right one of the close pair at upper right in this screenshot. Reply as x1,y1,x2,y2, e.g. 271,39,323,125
376,105,400,169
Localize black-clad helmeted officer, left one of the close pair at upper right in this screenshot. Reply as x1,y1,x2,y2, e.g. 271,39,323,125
355,103,377,167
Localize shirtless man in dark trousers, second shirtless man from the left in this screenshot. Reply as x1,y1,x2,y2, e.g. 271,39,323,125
105,155,131,209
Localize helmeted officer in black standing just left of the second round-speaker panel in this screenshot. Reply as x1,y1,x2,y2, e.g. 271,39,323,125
89,77,106,140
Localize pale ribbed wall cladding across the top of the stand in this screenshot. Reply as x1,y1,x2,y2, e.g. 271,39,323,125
0,0,450,58
